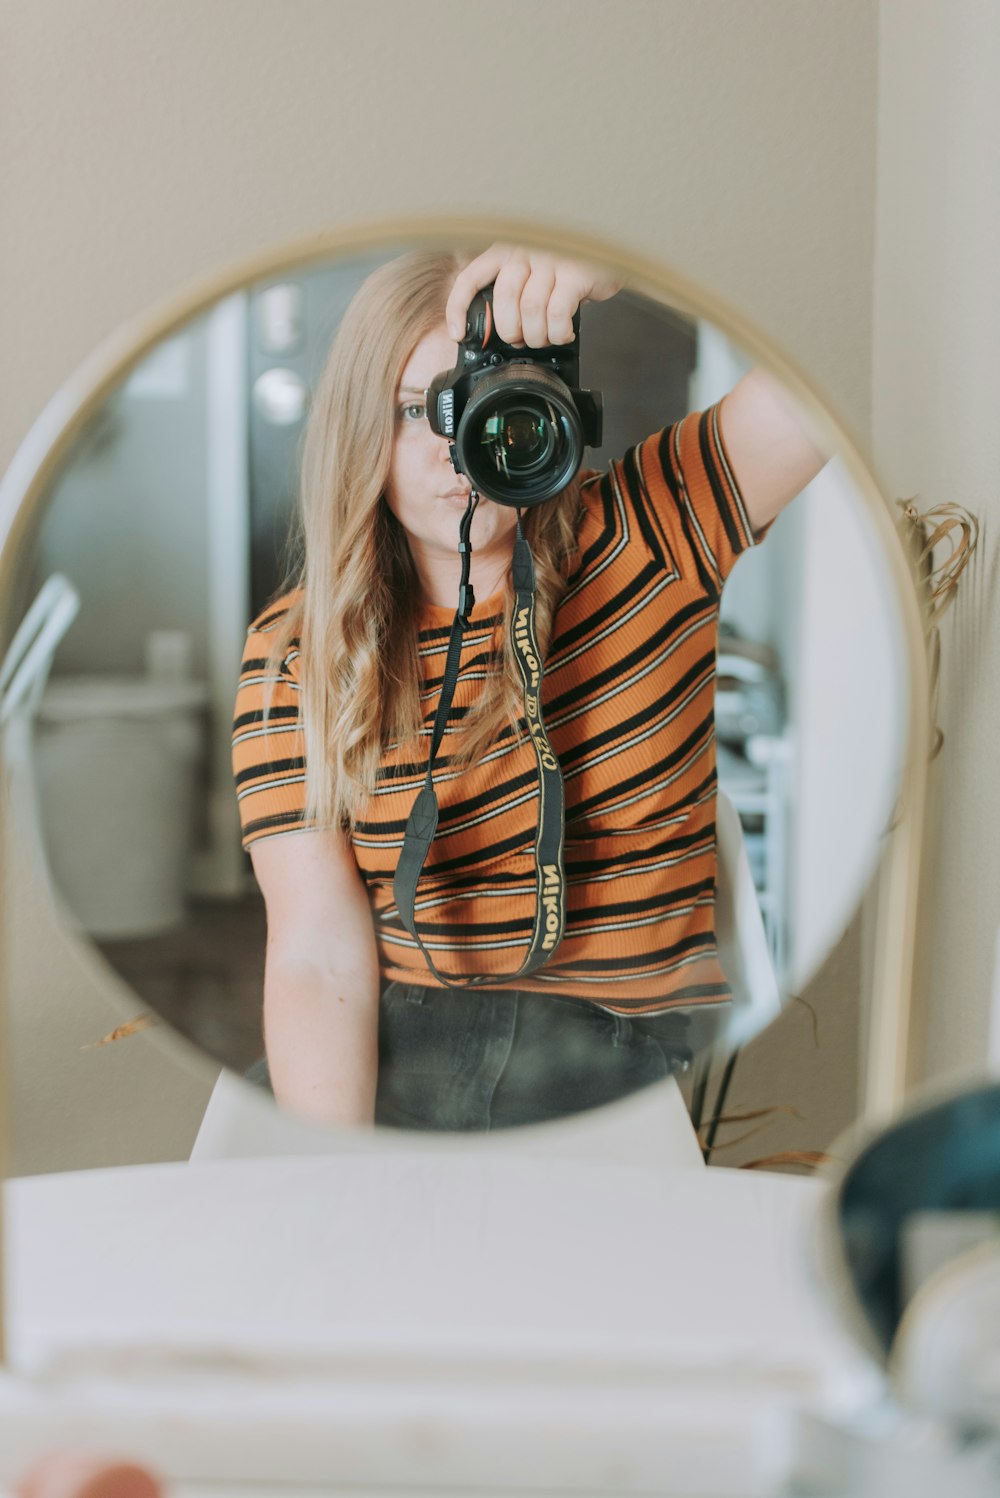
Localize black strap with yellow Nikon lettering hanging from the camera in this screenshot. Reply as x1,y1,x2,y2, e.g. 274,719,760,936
392,490,566,989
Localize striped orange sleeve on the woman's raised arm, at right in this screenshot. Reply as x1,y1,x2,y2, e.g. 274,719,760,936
635,401,766,596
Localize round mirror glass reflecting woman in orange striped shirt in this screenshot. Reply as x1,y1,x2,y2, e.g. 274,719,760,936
1,239,906,1129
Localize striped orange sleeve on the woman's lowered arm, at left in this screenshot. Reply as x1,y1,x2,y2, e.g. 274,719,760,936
232,611,308,848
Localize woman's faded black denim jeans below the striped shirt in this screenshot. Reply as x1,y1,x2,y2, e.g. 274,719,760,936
247,983,690,1131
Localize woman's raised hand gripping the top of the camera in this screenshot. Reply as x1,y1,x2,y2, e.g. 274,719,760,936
445,244,618,349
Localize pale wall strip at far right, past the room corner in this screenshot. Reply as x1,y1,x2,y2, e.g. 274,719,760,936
873,0,1000,1076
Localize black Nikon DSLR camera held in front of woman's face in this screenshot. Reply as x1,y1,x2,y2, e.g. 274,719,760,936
427,286,602,509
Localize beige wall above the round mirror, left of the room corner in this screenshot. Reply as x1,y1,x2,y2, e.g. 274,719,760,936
0,0,877,1168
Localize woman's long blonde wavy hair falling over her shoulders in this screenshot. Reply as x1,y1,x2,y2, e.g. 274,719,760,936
268,252,579,827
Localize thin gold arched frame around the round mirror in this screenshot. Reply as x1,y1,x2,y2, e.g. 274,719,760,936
0,216,930,1357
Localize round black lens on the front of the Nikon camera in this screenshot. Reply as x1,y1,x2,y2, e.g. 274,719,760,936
455,364,584,506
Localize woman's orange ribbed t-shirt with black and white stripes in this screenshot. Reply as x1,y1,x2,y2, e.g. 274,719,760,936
234,406,754,1014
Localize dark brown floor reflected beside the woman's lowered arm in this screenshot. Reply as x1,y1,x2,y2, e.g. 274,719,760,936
97,893,265,1071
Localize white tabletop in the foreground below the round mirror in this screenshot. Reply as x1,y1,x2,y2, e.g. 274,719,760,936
0,1126,867,1498
